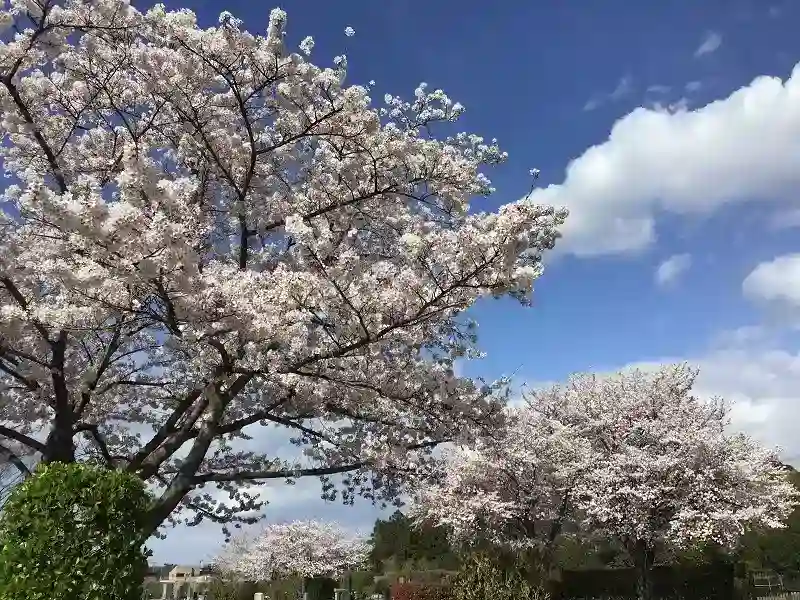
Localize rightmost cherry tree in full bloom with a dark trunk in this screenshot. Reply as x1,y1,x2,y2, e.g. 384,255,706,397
527,364,800,600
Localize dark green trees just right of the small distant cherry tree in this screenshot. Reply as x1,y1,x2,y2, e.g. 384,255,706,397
369,510,458,573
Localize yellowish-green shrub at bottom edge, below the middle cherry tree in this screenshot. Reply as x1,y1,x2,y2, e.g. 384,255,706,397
451,553,547,600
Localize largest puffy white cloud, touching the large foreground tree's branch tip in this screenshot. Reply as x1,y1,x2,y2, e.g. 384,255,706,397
533,64,800,256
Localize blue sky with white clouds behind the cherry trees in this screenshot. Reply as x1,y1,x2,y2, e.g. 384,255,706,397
125,0,800,562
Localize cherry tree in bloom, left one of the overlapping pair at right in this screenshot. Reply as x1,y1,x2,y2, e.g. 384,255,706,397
412,407,593,572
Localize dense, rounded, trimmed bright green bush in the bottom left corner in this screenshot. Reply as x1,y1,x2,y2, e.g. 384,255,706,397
0,463,150,600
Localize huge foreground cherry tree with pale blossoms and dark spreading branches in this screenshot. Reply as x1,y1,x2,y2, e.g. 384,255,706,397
0,0,566,531
